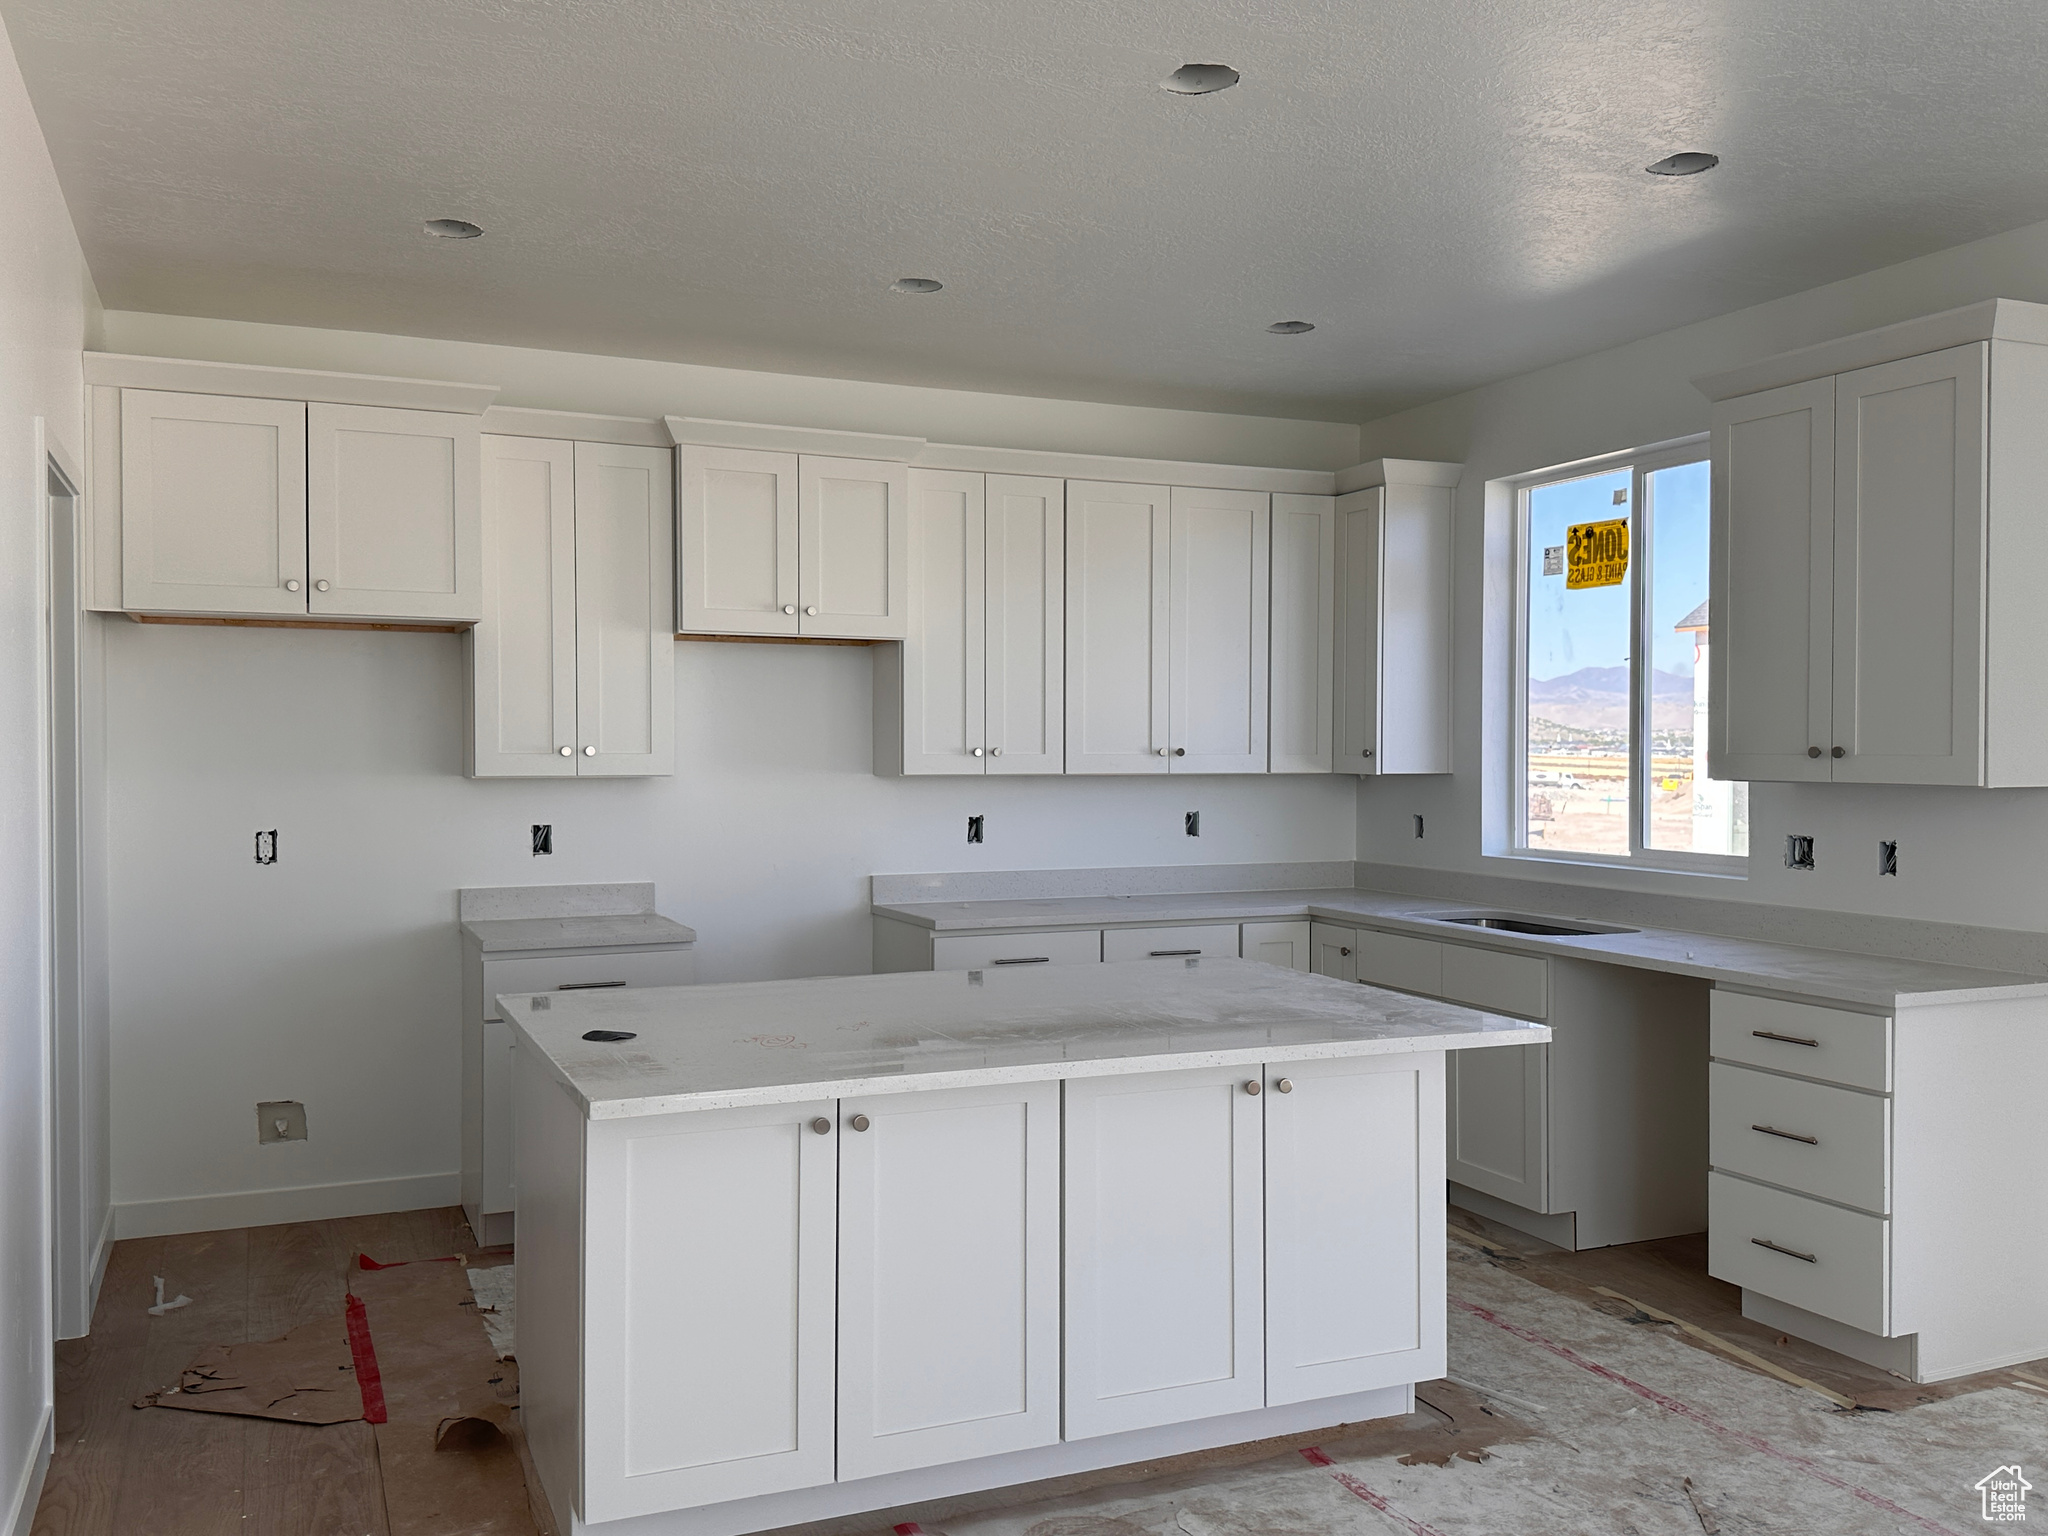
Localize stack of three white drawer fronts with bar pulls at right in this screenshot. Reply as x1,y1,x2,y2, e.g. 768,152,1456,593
1708,989,1892,1333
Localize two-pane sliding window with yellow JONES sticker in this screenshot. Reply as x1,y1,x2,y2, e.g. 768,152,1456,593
1513,442,1749,870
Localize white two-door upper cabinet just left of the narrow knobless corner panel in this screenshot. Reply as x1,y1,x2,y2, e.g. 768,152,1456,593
1067,481,1272,774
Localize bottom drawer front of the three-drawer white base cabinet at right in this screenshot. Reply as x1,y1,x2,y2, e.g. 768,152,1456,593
1706,1174,1892,1333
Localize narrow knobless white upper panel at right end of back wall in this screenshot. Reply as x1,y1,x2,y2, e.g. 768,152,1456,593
1272,494,1337,774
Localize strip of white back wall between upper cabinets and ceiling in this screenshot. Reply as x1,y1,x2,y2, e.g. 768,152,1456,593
104,309,1358,469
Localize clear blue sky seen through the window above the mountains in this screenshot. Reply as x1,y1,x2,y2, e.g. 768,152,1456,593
1528,461,1708,678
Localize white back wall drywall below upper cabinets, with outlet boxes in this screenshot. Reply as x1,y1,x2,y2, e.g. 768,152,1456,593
98,618,1356,1233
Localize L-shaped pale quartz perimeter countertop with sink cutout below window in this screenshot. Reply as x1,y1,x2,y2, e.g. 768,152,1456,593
872,889,2048,1010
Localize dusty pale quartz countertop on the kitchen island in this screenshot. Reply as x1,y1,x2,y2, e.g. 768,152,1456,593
500,958,1550,1120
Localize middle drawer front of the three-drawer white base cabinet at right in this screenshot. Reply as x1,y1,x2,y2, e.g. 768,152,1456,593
1708,1061,1892,1214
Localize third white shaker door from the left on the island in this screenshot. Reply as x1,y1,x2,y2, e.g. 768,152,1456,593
1065,1067,1266,1440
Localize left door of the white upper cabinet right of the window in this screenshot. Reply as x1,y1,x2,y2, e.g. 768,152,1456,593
1706,379,1835,780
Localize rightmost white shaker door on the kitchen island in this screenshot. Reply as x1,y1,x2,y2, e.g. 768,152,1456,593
1266,1051,1441,1405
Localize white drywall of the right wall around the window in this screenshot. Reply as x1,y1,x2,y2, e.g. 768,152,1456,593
1358,223,2048,932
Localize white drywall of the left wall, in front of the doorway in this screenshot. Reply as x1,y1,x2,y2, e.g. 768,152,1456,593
0,15,98,1530
